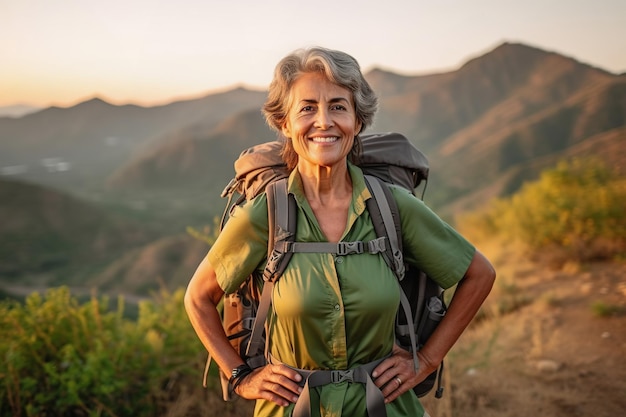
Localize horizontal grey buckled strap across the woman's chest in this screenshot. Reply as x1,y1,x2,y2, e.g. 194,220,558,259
275,236,387,256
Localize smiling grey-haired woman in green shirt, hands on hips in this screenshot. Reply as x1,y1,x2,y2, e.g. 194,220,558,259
185,48,495,417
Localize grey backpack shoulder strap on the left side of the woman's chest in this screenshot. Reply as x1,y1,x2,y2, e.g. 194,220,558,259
246,178,297,360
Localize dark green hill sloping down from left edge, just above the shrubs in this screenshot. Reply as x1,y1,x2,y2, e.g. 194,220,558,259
0,180,154,286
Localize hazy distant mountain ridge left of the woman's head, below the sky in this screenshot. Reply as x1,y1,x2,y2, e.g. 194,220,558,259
0,88,265,194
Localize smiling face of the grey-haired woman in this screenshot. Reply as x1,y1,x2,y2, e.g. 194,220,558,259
282,73,362,171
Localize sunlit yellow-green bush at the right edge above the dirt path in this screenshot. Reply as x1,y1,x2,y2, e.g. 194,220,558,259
458,159,626,260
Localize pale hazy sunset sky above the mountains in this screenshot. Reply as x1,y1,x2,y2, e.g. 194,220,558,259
0,0,626,106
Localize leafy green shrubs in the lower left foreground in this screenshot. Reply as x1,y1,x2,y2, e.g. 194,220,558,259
0,288,203,416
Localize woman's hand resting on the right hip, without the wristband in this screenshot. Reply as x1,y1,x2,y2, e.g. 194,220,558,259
372,344,437,403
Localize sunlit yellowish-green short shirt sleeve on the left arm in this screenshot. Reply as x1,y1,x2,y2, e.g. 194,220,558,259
208,194,268,294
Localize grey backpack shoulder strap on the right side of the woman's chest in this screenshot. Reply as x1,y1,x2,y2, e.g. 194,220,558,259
365,175,419,372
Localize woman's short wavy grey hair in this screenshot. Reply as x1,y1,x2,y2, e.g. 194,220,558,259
262,47,378,169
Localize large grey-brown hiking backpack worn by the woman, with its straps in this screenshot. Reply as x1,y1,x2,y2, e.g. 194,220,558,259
204,133,447,401
